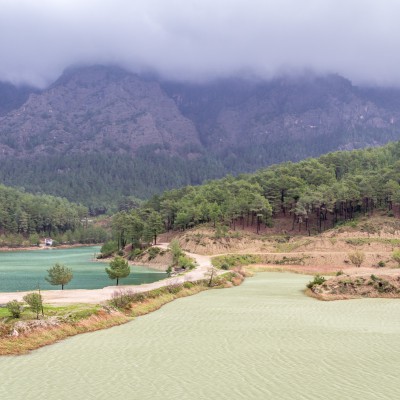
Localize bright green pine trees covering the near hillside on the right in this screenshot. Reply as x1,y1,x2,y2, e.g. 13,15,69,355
113,142,400,246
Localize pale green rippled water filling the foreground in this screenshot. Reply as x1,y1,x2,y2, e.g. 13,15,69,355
0,273,400,400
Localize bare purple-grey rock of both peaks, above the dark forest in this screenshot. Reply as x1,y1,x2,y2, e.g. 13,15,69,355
0,66,400,162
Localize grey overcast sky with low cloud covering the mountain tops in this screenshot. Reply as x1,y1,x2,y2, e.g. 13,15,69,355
0,0,400,87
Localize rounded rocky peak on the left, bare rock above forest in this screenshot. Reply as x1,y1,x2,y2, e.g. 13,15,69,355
0,67,199,155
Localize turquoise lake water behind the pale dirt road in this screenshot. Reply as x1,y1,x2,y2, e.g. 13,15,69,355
0,246,166,292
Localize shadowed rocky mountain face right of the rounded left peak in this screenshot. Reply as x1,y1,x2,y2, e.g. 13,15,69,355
162,76,400,157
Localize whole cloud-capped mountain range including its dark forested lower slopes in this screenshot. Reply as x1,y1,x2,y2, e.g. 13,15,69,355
0,66,400,212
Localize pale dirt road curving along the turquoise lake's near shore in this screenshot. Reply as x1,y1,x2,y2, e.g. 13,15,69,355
0,243,211,304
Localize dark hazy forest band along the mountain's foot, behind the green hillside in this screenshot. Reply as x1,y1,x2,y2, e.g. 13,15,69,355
0,135,382,215
